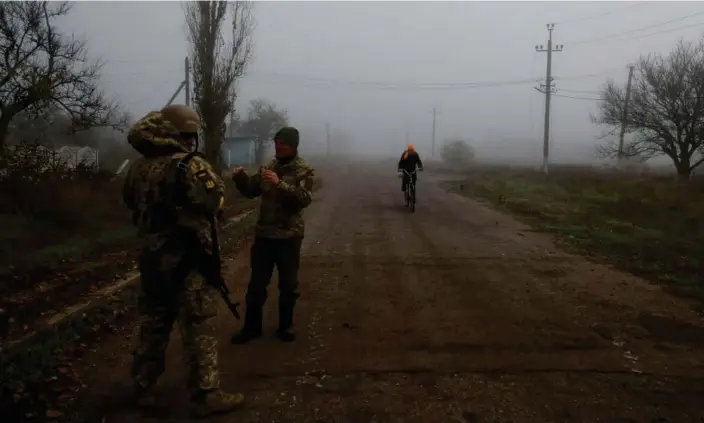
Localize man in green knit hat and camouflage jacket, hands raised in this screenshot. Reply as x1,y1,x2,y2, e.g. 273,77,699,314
232,127,314,344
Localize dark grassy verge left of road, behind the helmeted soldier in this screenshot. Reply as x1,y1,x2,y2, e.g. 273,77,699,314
0,177,258,342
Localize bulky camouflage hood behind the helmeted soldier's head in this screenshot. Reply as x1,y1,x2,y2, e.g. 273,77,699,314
127,112,189,156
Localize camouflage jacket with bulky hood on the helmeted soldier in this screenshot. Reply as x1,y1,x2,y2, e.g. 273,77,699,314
123,112,225,258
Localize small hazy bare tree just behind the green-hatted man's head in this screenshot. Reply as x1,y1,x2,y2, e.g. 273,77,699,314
241,99,288,164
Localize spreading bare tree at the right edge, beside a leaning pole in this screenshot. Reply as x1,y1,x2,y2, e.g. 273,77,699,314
592,40,704,180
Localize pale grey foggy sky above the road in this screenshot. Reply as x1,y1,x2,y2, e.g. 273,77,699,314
64,2,704,163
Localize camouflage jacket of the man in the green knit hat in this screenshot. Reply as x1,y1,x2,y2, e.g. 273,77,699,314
233,156,315,239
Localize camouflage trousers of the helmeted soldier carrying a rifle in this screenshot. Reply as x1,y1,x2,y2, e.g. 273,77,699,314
131,266,220,395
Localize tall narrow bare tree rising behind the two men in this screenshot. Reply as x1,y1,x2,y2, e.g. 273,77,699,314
184,0,253,168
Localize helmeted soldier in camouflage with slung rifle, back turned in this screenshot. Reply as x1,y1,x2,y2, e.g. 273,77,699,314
123,105,244,417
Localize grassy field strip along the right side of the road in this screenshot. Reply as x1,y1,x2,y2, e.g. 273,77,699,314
446,167,704,300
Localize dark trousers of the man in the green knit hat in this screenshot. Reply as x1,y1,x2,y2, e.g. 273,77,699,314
246,238,303,309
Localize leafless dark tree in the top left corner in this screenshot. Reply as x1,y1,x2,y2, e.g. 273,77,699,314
0,1,120,147
